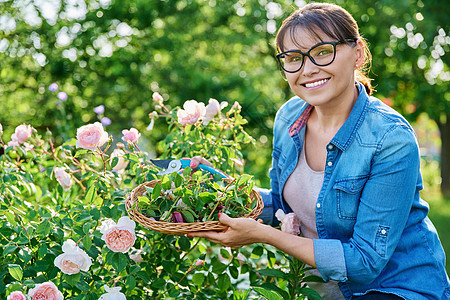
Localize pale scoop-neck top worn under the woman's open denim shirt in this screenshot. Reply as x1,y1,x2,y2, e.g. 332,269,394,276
283,144,345,300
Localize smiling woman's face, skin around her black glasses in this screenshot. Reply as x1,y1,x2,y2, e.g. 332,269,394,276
284,28,364,108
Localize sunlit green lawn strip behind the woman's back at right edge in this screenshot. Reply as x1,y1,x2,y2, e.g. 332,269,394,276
422,194,450,274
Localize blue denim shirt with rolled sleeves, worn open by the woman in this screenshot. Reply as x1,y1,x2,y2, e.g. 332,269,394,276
260,83,450,300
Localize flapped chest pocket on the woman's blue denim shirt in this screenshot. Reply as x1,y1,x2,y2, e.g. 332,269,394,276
333,176,368,220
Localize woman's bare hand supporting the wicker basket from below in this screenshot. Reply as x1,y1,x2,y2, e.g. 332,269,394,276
188,213,267,249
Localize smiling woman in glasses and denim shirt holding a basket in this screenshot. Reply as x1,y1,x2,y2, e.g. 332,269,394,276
192,3,450,299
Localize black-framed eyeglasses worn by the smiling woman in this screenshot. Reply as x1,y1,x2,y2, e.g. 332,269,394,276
277,39,356,73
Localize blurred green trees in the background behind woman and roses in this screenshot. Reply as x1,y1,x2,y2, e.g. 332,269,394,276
0,0,450,195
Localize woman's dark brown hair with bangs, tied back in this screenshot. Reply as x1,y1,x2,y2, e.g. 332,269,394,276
276,3,374,95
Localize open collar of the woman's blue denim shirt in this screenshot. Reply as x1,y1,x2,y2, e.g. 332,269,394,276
289,82,369,151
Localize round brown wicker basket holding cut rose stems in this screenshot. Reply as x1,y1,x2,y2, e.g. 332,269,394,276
125,179,264,235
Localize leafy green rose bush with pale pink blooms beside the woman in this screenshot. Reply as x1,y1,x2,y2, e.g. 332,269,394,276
0,87,324,300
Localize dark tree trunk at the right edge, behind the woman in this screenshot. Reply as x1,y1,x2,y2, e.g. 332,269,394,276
439,116,450,198
